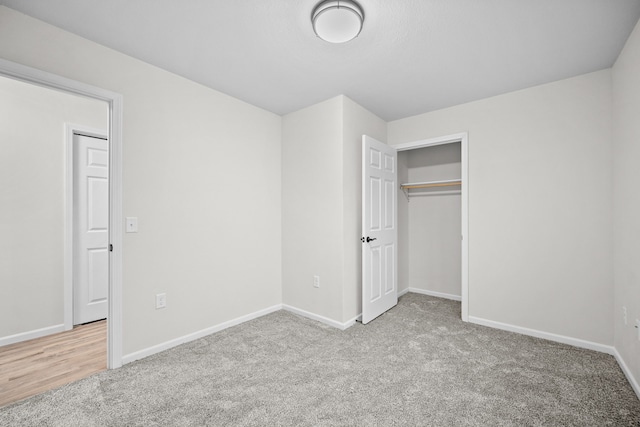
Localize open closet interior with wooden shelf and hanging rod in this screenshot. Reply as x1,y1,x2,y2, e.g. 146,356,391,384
398,142,462,301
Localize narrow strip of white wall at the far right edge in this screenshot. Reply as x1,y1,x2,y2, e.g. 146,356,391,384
613,18,640,396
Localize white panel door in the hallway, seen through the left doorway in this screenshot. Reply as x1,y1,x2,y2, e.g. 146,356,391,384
73,134,109,325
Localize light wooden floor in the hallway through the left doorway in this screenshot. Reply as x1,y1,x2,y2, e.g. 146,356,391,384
0,320,107,407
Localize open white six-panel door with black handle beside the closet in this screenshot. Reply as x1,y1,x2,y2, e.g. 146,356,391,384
362,135,398,323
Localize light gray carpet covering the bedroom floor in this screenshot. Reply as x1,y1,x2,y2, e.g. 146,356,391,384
0,294,640,426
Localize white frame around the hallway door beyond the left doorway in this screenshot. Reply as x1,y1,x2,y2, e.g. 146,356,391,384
64,123,111,331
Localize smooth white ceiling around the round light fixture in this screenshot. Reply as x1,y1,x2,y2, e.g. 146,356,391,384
0,0,640,121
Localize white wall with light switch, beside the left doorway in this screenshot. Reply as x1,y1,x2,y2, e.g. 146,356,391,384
0,7,281,356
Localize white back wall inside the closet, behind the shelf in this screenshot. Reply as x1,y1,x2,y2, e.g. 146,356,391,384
407,143,462,298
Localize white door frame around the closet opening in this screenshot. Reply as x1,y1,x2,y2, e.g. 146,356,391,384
392,132,469,322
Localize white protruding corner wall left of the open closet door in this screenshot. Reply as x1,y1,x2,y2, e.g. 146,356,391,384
282,96,386,324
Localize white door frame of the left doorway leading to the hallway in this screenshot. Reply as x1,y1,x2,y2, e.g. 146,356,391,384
0,58,123,369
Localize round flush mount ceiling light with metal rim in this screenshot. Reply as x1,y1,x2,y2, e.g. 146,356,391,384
311,0,364,43
